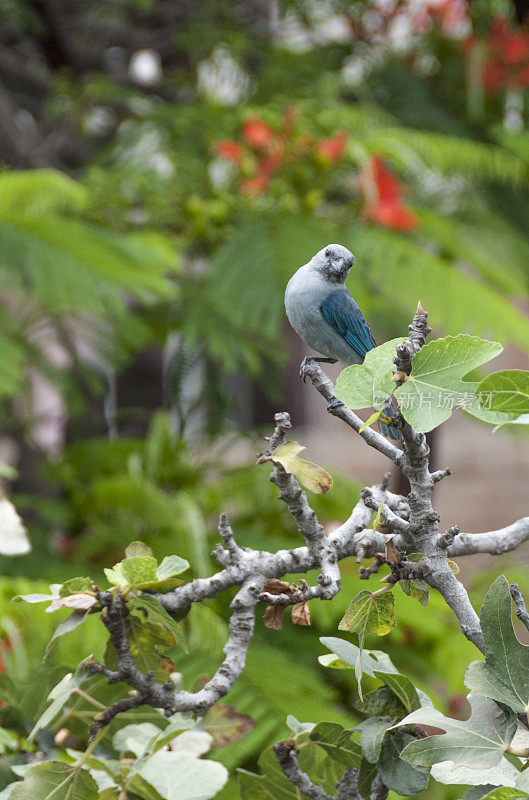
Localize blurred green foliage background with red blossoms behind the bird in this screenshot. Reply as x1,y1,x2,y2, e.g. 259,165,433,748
0,0,529,798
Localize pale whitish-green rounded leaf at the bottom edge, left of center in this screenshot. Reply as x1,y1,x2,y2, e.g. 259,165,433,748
125,750,228,800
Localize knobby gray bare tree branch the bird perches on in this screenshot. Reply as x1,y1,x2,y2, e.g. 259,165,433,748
84,304,529,736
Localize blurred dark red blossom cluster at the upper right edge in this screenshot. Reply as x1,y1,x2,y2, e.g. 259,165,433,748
464,17,529,93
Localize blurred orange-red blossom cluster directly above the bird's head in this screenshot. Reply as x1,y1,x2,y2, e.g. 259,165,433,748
213,107,349,197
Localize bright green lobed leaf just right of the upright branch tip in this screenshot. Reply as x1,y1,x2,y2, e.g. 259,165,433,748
395,334,503,433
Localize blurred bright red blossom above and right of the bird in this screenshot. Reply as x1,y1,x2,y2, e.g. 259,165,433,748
358,156,419,231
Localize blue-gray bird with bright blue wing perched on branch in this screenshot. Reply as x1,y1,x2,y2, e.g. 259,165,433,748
285,244,400,439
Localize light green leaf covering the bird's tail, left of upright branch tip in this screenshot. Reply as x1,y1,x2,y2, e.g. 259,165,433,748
334,338,404,410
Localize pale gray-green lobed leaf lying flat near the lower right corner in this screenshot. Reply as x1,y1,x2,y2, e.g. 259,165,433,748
397,695,517,769
